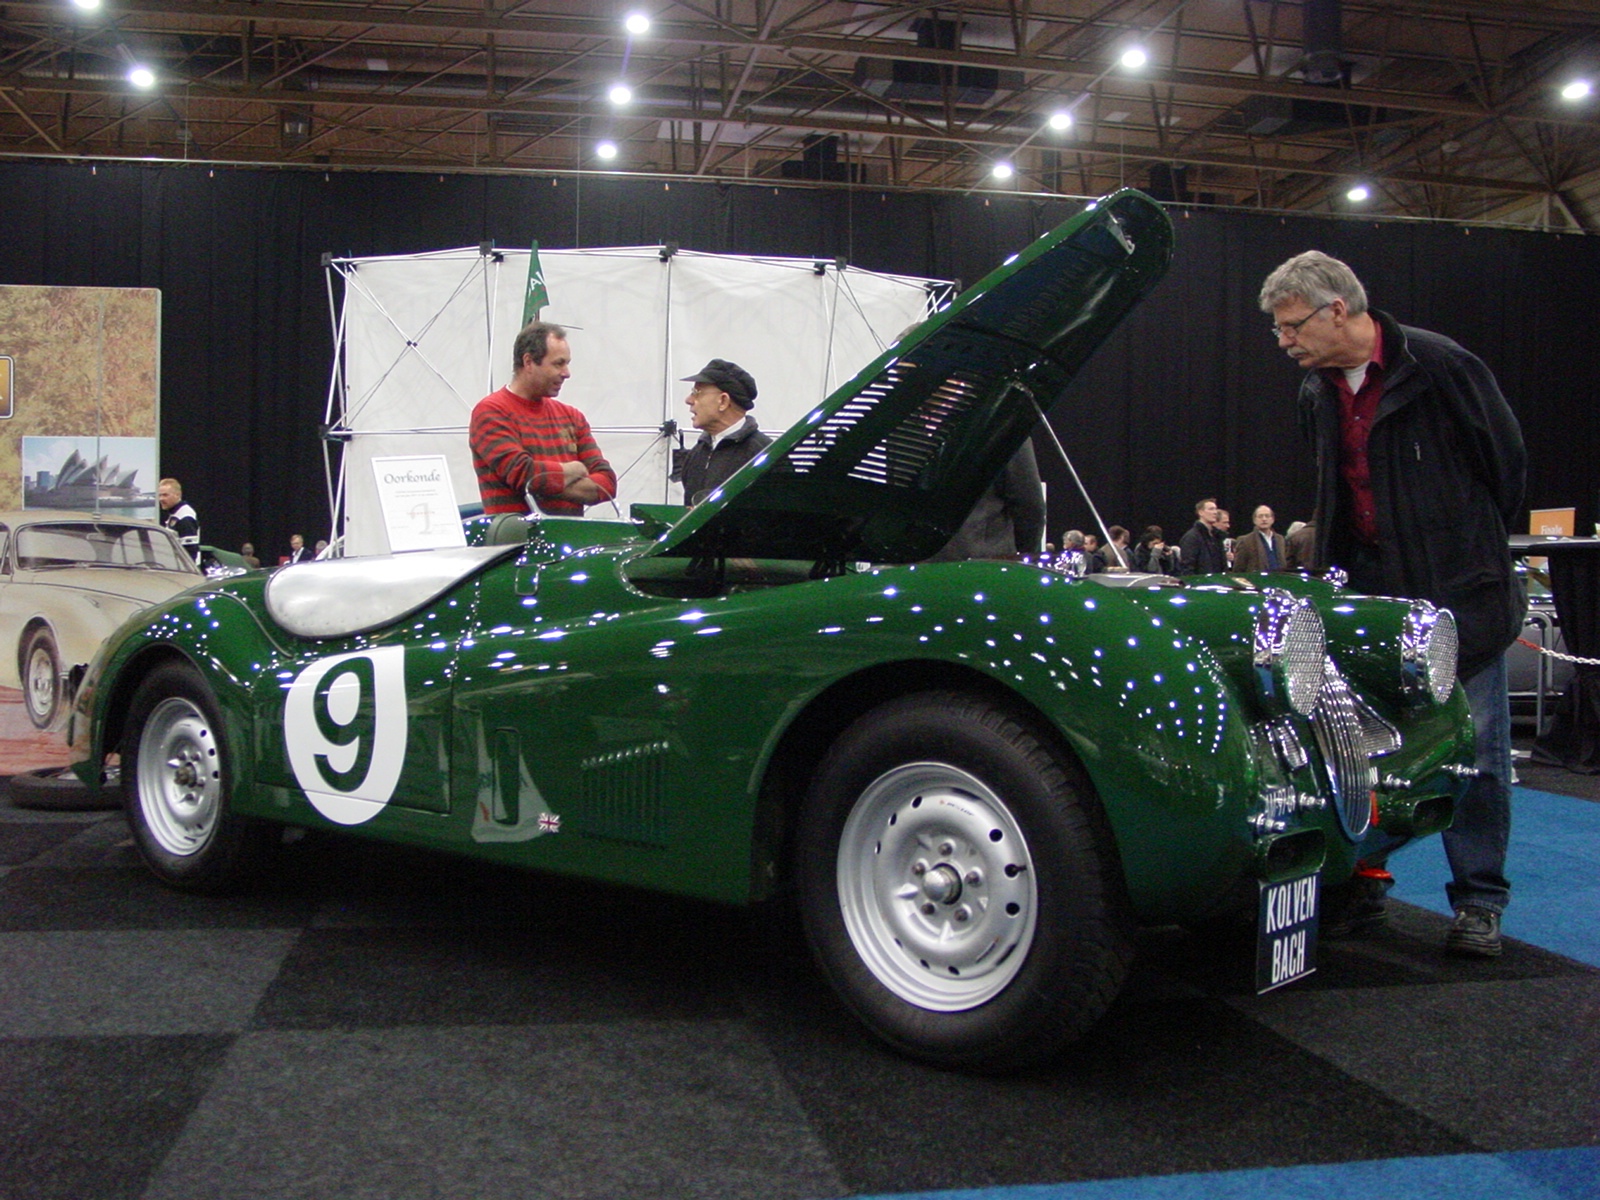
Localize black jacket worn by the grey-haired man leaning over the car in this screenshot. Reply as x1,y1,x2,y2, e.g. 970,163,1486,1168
1299,309,1528,678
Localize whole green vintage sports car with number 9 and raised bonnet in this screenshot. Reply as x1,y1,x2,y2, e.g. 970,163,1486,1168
70,192,1472,1070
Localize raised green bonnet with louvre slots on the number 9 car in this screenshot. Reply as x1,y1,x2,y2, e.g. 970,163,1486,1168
653,190,1173,573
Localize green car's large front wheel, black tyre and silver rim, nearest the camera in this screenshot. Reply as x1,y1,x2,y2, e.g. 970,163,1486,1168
795,693,1133,1070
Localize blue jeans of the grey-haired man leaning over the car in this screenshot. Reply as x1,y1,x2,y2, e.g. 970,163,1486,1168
1445,654,1512,912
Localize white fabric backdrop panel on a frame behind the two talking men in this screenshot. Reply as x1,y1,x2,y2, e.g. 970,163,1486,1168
328,246,930,554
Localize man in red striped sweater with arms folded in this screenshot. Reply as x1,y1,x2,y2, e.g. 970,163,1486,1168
467,322,616,517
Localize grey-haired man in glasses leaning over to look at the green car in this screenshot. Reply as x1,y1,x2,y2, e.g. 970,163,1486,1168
1259,250,1526,957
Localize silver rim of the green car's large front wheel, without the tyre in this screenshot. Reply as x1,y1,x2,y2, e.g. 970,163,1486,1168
838,763,1038,1013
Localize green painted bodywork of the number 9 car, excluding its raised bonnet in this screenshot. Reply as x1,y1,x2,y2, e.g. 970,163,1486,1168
75,522,1470,922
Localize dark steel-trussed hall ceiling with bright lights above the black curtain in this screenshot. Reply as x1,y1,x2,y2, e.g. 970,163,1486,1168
9,0,1600,232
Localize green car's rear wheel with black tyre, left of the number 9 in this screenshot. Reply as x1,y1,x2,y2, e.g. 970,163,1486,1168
122,664,272,893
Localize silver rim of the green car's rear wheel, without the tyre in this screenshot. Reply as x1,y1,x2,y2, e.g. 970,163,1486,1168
134,696,222,856
